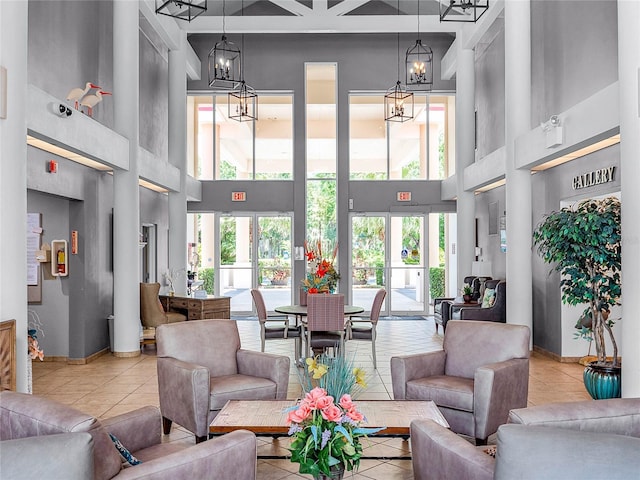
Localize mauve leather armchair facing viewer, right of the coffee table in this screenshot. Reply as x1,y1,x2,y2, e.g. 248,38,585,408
391,320,530,444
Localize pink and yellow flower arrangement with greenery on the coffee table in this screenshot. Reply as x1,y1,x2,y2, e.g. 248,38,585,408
287,355,382,479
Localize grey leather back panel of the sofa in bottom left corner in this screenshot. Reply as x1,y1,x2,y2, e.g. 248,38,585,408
0,432,93,480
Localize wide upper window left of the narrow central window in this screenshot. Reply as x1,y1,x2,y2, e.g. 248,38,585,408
187,94,293,180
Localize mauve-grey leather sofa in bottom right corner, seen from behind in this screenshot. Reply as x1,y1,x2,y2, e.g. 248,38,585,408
411,398,640,480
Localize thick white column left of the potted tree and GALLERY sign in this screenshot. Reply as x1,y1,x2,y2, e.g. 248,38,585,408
504,0,533,334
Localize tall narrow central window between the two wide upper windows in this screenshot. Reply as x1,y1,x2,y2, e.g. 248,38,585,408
305,63,337,242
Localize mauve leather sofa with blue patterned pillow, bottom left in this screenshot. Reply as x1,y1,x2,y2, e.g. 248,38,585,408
0,391,257,480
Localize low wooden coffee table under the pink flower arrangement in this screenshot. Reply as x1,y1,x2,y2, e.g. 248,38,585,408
209,400,449,436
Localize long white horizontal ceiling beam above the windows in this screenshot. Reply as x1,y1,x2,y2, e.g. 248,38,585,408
180,15,461,33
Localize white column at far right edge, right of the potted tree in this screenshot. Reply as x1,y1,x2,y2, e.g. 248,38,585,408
616,0,640,397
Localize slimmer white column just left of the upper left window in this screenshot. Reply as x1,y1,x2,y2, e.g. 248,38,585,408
169,30,188,295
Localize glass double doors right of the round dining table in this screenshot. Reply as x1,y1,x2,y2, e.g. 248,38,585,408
350,213,428,315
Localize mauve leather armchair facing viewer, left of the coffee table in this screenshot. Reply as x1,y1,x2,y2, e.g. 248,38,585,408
157,320,290,442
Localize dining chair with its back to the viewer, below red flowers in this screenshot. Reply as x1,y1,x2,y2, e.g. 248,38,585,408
305,293,345,357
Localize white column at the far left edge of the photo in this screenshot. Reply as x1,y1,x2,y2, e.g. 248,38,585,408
0,2,28,392
